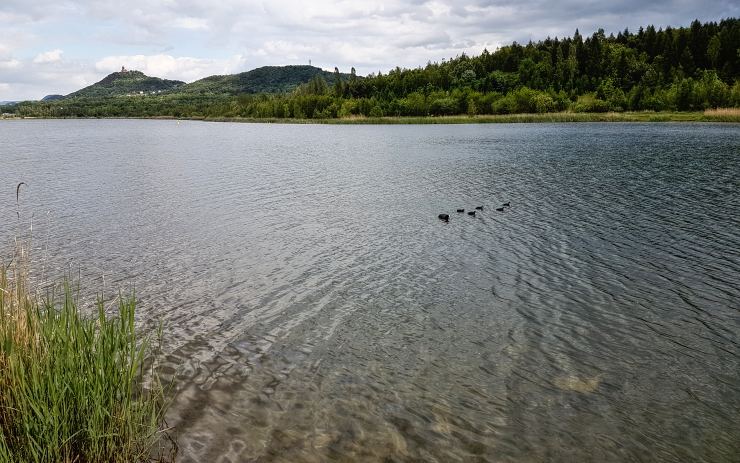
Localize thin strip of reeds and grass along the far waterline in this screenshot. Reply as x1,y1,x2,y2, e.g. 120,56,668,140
0,108,740,125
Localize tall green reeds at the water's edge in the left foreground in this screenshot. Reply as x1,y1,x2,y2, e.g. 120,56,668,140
0,245,174,463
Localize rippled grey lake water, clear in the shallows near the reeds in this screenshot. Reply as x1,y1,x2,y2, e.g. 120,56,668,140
0,121,740,462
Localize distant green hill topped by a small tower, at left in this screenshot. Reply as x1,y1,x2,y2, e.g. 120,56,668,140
66,70,185,98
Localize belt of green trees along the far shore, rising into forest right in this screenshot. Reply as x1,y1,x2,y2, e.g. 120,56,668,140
2,18,740,119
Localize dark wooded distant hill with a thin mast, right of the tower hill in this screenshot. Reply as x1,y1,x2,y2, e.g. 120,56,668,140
178,65,349,95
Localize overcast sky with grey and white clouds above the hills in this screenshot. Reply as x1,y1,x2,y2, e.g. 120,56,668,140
0,0,740,101
